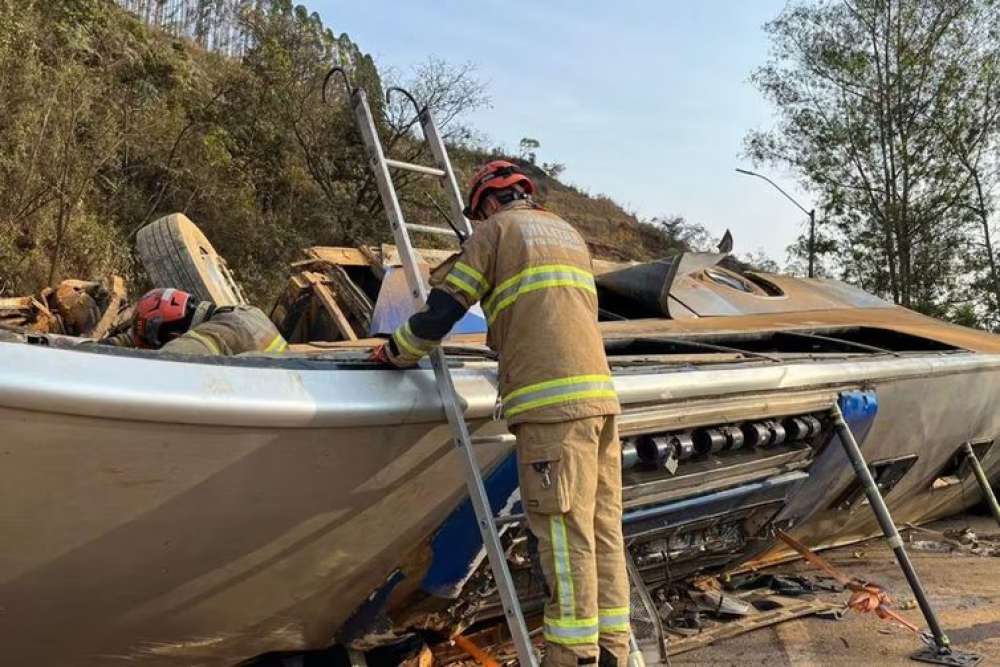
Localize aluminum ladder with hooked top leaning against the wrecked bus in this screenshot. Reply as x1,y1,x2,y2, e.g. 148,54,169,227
323,67,538,667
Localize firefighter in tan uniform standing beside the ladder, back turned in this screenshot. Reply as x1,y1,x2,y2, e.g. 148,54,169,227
373,160,629,667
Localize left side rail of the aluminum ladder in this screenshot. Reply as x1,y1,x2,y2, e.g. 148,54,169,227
352,88,538,667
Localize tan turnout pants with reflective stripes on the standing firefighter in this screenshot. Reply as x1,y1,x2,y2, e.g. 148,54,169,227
513,416,629,667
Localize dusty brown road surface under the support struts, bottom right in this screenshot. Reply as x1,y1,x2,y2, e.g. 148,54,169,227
671,515,1000,667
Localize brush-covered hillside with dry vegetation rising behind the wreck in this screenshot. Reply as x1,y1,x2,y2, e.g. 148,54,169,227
0,0,679,305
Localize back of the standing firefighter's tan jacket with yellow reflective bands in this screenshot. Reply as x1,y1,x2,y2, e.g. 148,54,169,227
482,205,619,423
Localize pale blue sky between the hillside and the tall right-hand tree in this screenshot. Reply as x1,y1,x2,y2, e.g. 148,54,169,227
306,0,810,263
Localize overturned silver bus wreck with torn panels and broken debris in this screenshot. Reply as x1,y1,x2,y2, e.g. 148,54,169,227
0,216,1000,665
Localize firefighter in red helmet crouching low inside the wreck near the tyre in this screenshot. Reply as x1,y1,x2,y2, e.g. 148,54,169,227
100,288,288,356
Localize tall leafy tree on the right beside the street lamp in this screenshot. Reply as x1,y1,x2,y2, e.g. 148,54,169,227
746,0,995,312
